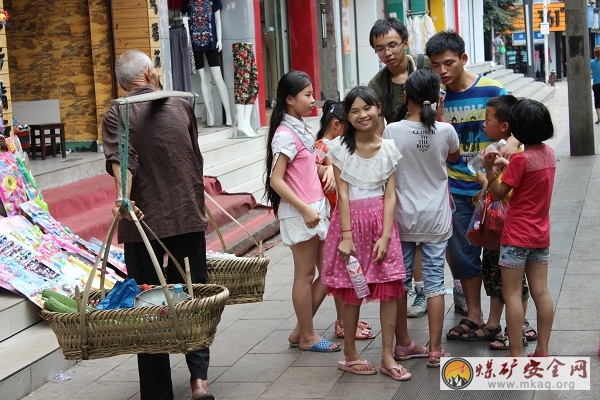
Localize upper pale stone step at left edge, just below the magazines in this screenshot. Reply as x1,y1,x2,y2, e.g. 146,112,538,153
0,288,41,342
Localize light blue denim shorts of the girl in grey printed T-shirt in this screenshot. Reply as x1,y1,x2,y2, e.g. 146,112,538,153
401,240,447,298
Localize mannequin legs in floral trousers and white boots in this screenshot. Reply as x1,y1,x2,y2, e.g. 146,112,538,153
231,43,258,137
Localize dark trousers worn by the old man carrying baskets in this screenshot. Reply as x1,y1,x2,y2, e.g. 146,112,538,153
125,232,210,400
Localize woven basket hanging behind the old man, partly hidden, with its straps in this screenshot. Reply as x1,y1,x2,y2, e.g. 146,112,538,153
204,192,270,305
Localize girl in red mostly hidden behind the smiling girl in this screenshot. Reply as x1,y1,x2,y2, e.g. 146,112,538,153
316,100,375,340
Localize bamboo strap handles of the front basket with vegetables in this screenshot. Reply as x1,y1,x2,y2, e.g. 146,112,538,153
79,210,188,360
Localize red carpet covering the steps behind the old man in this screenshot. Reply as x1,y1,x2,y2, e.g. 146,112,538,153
42,174,279,255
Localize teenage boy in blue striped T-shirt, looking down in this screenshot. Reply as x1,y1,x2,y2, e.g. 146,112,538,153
425,30,519,340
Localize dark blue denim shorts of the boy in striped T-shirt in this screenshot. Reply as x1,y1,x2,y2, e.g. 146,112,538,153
448,194,481,279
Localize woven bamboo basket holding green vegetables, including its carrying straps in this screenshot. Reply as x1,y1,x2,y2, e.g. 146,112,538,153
42,191,229,360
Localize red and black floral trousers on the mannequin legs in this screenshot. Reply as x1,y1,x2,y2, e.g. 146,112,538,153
231,43,259,104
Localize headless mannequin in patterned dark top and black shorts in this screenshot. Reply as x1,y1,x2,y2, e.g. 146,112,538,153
187,0,232,126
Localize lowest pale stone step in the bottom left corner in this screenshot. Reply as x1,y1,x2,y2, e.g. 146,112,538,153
0,321,75,400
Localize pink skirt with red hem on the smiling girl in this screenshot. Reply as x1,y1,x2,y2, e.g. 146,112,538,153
321,197,406,305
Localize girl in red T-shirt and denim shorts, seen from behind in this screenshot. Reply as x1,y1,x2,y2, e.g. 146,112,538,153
483,99,556,357
